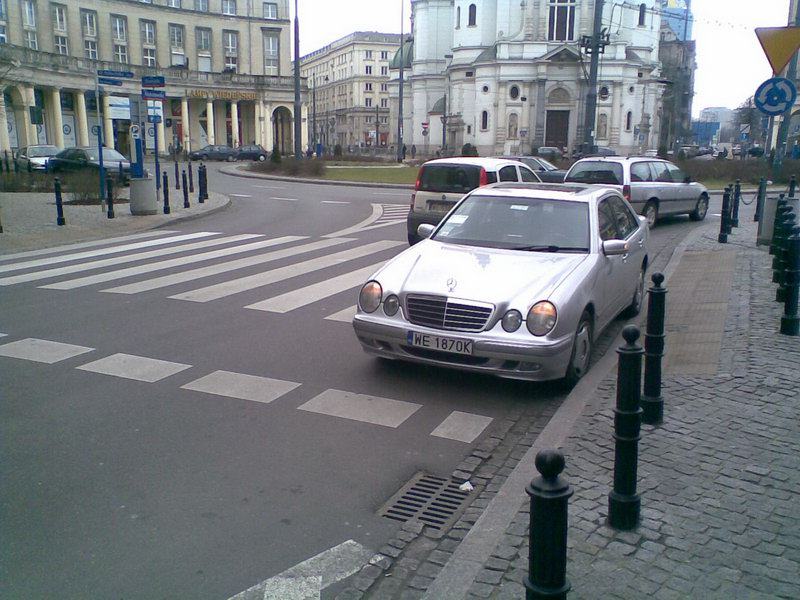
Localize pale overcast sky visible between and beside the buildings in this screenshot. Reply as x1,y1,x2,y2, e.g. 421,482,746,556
290,0,789,116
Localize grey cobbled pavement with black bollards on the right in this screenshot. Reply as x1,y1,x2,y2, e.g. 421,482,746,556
337,207,800,600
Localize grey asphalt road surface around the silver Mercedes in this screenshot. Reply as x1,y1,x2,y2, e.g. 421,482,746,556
0,166,718,599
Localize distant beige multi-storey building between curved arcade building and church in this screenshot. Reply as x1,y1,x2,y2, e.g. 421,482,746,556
300,31,400,147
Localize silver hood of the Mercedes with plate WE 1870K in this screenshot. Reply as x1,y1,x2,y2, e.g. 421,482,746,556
376,240,588,305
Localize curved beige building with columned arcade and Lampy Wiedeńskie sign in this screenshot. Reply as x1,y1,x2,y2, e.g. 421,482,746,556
0,0,305,154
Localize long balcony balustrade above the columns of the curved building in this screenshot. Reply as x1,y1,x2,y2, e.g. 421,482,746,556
0,44,306,91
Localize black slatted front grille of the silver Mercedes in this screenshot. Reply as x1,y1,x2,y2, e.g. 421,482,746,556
406,296,494,331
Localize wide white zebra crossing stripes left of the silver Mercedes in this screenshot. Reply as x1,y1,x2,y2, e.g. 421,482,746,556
0,227,406,322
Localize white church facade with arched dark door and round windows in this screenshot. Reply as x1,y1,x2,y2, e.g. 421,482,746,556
390,0,666,155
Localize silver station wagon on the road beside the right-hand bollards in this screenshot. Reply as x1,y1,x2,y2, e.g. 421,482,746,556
564,156,708,227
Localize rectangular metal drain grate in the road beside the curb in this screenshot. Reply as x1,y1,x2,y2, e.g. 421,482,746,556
378,472,473,529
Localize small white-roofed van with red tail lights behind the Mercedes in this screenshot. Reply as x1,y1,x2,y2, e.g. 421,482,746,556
406,156,541,244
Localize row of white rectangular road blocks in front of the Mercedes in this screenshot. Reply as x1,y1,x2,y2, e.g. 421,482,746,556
0,334,493,444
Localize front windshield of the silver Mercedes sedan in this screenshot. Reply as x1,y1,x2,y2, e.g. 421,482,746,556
432,195,589,252
